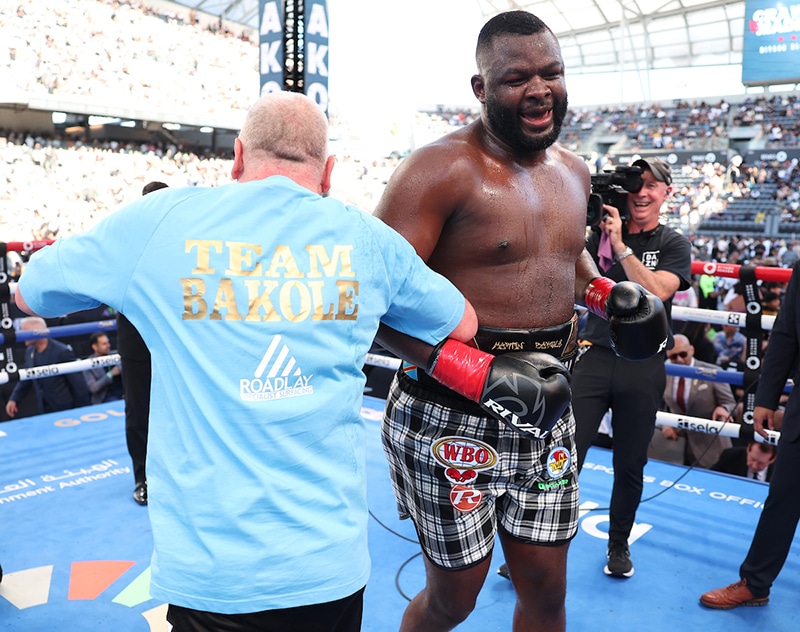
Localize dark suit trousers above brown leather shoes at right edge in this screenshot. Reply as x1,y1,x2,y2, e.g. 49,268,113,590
739,439,800,597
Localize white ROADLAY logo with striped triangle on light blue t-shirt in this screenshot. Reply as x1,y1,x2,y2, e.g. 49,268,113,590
239,335,314,402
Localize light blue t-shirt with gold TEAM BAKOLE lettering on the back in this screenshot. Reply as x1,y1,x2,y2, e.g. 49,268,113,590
19,176,465,614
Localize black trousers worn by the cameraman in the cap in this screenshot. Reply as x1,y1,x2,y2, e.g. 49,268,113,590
572,345,667,542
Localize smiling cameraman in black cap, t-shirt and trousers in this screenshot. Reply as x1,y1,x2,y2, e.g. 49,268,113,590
572,158,691,577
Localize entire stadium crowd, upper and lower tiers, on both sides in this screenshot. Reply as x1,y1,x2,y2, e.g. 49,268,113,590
0,0,800,239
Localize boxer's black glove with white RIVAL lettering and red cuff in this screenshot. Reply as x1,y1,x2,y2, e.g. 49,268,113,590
426,339,572,439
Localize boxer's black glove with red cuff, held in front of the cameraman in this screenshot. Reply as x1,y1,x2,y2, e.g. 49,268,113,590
584,277,669,360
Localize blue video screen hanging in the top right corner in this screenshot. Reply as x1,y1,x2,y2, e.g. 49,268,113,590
742,0,800,86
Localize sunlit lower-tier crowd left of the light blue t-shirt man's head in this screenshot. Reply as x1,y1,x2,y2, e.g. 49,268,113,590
0,133,231,241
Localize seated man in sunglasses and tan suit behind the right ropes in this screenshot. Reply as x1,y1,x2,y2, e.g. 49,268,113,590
661,334,736,468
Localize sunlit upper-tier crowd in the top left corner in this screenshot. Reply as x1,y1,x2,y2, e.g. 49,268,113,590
0,0,259,115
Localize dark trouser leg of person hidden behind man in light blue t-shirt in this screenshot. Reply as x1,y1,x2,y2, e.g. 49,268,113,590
117,314,152,485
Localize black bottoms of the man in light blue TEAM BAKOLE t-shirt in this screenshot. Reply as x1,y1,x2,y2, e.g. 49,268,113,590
167,588,364,632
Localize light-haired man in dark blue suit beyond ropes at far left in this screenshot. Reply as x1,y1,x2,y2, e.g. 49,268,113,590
6,317,89,417
